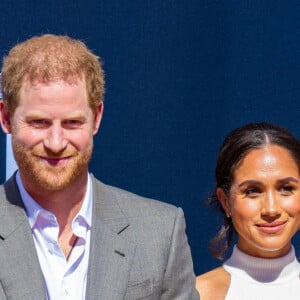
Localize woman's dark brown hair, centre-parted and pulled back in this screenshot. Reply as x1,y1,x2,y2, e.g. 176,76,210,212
209,122,300,260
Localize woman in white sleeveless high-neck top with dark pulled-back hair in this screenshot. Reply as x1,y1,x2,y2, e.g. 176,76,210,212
197,123,300,300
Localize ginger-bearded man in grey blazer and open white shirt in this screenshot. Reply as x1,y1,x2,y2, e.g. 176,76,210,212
0,35,199,300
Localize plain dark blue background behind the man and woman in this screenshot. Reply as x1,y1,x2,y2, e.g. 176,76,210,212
0,0,300,274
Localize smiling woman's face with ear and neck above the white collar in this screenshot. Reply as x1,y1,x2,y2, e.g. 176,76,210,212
217,145,300,258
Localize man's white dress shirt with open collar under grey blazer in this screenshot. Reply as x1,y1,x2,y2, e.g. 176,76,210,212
16,173,93,300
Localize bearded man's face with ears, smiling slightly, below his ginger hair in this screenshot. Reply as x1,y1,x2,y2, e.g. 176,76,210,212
1,79,102,191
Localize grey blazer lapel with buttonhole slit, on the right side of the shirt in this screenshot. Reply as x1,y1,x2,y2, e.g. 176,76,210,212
86,179,135,300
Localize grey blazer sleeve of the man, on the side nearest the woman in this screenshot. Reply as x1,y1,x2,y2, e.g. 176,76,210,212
161,208,200,300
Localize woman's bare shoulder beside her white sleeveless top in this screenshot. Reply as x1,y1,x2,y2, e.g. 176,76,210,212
196,267,230,300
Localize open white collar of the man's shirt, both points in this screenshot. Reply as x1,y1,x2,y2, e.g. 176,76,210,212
16,172,93,228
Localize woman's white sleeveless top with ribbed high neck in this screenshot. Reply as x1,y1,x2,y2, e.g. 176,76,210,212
223,246,300,300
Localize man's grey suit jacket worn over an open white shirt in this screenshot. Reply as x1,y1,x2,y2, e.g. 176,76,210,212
0,176,199,300
